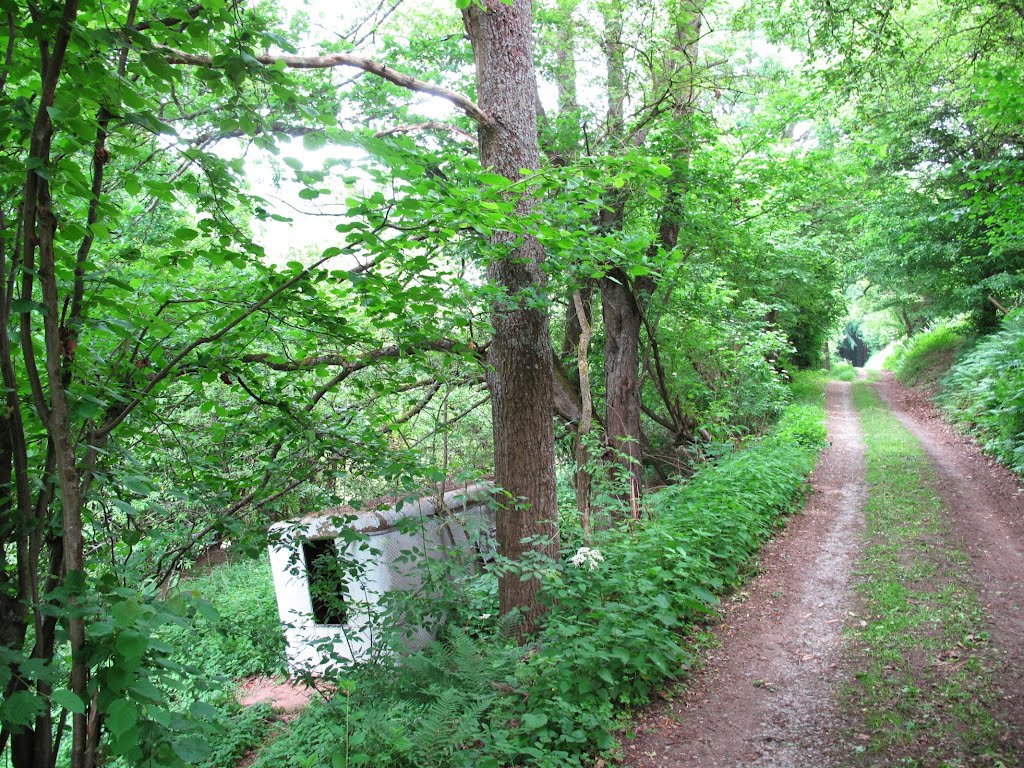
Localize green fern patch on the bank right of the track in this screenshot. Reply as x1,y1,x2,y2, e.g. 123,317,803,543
938,311,1024,474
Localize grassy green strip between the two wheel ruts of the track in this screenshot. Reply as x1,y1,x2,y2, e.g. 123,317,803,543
843,382,1021,768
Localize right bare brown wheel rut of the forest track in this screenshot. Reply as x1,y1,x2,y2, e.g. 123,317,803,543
877,375,1024,754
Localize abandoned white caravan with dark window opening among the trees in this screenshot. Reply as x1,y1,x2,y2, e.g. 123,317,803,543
269,484,495,676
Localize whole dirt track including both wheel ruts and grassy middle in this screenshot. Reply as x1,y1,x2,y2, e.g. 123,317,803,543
625,376,1024,768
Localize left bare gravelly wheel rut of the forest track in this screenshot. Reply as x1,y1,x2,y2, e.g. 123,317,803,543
625,382,867,768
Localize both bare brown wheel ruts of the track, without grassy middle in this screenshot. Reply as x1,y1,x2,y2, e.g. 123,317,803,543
626,378,1024,768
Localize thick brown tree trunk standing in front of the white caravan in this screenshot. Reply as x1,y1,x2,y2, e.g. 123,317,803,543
464,0,559,636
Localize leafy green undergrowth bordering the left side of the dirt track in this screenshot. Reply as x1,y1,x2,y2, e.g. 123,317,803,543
228,375,825,768
